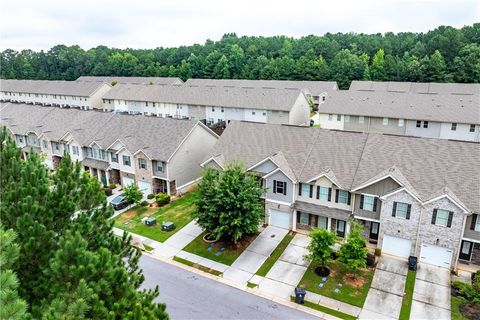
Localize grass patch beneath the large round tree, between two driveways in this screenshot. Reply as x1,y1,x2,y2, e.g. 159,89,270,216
183,231,257,266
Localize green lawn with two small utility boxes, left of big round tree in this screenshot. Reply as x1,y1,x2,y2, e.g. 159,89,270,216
114,193,195,242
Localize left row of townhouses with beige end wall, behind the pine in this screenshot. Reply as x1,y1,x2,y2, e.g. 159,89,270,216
0,103,218,195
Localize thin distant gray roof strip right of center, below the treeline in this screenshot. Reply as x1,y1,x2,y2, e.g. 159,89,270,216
185,79,338,96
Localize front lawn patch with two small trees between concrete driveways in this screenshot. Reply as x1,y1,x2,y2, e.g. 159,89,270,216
299,261,374,308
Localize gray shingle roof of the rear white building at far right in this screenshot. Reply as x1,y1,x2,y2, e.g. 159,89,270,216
319,90,480,124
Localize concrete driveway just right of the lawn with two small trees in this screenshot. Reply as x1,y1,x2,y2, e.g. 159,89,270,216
359,256,406,319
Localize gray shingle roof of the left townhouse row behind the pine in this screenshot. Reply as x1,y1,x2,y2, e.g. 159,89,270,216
0,103,206,161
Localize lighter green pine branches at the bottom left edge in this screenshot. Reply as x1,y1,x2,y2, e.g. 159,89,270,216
0,225,27,320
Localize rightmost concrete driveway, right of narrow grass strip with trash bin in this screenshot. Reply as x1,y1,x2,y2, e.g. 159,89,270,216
410,263,451,320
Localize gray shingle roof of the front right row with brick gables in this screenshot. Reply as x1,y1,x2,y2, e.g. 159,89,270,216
205,121,480,212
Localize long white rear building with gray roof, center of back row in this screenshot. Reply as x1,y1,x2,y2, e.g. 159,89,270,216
103,84,310,125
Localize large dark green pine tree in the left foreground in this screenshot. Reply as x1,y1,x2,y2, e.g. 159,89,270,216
0,130,168,319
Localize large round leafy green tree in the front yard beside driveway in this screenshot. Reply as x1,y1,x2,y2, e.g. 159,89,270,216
195,163,264,243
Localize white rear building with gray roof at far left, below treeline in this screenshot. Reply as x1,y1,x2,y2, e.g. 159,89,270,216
0,80,111,110
